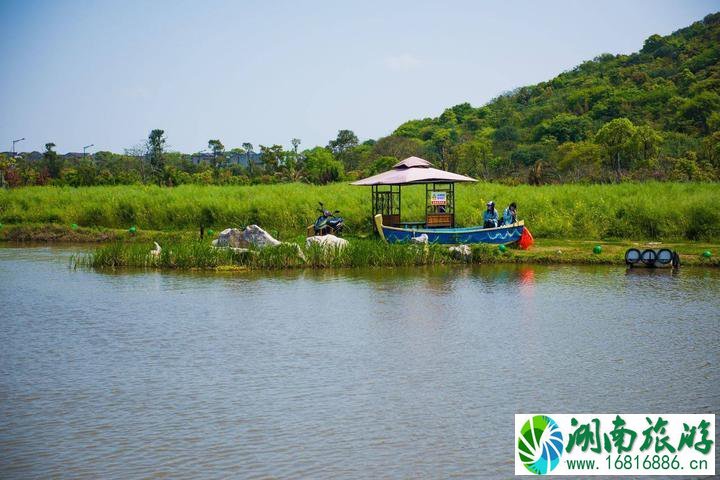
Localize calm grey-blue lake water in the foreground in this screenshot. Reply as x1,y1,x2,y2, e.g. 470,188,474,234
0,247,720,478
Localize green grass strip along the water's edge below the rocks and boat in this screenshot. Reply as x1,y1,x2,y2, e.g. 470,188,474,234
73,238,720,270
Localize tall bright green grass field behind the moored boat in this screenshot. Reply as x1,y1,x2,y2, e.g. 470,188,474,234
0,182,720,242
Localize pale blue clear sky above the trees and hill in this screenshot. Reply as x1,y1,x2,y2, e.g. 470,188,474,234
0,0,720,153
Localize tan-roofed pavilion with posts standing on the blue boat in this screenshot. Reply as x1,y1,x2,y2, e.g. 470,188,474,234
352,157,477,228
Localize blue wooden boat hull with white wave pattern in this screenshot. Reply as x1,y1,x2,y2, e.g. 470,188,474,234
375,214,525,245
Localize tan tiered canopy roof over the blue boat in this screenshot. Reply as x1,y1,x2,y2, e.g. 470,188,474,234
351,157,477,186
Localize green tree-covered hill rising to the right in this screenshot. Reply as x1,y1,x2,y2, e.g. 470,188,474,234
354,13,720,183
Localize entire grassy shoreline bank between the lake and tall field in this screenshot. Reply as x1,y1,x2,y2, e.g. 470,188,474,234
0,224,720,271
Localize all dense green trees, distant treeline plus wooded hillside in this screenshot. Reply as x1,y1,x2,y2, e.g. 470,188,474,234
0,13,720,186
